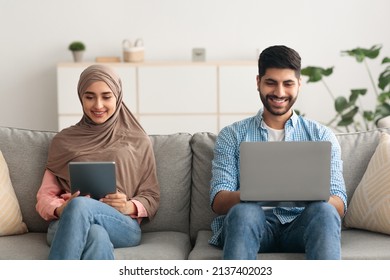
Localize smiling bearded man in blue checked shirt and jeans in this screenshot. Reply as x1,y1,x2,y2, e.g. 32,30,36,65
209,46,347,260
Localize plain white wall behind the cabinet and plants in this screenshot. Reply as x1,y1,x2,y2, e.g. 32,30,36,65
0,0,390,130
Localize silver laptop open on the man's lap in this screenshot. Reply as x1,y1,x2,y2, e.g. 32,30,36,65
240,141,331,206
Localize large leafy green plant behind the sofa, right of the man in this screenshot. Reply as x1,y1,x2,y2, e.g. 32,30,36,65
301,45,390,132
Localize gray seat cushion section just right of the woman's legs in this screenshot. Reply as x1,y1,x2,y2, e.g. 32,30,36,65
114,231,191,260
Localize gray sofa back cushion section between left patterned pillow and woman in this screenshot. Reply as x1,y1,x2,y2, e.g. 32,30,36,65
0,127,55,232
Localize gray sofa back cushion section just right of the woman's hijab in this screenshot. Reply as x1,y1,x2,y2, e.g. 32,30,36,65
142,133,192,233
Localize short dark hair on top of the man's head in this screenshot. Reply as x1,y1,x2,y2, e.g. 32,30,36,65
258,46,301,78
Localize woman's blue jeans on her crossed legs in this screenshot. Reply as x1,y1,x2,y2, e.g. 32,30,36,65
47,197,141,260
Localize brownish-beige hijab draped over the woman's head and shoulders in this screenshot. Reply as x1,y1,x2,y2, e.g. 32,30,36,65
47,65,160,218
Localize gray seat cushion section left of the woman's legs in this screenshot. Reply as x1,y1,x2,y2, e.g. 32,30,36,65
0,232,50,260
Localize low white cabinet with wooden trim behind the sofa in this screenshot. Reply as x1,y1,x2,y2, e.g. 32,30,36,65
57,62,261,134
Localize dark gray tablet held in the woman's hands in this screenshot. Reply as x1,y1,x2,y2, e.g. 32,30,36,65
69,162,116,199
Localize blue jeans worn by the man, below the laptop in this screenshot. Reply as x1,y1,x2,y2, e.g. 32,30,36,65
222,202,341,260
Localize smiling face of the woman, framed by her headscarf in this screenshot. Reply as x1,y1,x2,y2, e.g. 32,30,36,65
81,81,117,124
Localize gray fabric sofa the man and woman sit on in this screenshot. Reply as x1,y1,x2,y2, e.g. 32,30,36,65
0,127,390,260
